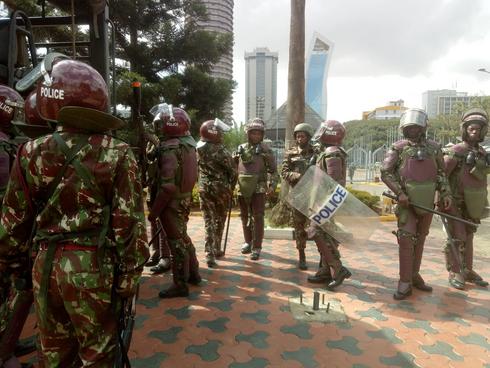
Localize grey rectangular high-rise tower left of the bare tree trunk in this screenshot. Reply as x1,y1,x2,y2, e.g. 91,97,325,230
245,47,279,121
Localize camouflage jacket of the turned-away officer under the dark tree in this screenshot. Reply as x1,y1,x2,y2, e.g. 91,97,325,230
197,141,237,195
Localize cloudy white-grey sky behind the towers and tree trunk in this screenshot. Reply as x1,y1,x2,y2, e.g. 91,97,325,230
233,0,490,122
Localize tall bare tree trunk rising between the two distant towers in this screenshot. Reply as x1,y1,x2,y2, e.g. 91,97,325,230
285,0,305,148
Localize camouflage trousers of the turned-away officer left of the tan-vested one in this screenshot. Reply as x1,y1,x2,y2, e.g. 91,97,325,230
199,192,231,257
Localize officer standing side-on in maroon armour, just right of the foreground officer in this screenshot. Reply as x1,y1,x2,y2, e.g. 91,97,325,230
148,104,201,298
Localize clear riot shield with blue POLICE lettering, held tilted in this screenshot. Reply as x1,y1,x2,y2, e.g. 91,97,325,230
285,166,381,244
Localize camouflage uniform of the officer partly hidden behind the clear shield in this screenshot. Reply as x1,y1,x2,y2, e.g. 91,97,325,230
281,143,315,258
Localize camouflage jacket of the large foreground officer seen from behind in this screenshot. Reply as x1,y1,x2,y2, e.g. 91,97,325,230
0,127,148,281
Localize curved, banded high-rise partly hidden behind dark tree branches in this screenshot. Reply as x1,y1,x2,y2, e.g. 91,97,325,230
197,0,234,119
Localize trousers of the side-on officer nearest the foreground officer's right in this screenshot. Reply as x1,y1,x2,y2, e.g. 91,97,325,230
160,198,199,285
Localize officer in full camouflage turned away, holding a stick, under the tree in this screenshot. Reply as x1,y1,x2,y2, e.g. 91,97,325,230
197,119,237,267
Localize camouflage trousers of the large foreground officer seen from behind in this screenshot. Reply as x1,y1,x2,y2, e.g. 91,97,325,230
33,247,119,367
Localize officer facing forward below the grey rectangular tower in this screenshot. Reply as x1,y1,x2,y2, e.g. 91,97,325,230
233,118,278,261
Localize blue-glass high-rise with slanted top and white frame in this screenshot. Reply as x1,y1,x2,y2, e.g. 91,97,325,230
305,32,333,119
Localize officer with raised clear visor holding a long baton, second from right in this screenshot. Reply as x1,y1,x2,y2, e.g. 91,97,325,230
381,109,451,300
